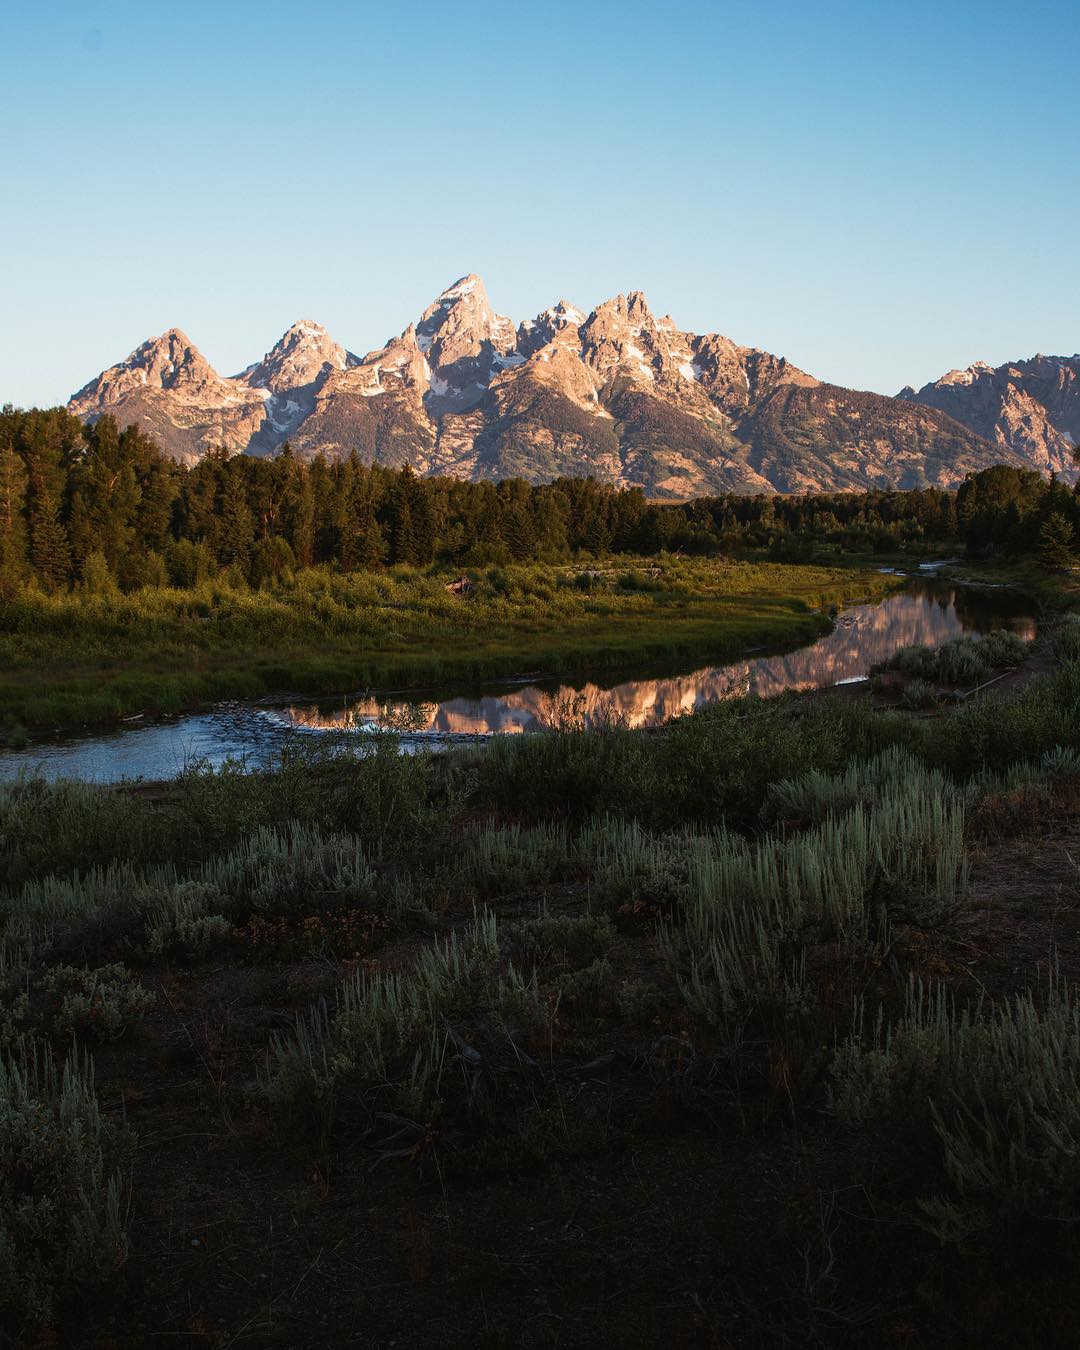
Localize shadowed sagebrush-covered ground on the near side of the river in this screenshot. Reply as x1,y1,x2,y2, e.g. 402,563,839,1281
0,615,1080,1347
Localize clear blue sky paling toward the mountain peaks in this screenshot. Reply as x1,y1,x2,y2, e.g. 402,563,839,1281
0,0,1080,405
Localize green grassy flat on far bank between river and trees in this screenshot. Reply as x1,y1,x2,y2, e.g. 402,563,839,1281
0,559,903,743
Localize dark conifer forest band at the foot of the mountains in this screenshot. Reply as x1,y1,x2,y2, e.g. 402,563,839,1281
0,406,1080,590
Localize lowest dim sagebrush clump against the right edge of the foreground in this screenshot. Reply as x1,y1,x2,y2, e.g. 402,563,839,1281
832,980,1080,1243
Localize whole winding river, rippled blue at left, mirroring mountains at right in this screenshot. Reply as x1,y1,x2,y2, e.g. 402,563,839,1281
0,581,1035,783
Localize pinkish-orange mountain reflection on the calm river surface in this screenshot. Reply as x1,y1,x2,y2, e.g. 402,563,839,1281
278,586,1035,736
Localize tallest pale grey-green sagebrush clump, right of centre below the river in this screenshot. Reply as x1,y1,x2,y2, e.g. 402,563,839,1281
663,752,968,1053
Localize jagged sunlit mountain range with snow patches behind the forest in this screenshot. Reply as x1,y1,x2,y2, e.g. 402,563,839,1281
68,274,1080,500
